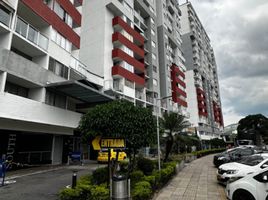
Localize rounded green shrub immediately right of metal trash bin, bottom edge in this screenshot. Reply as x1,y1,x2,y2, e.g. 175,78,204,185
132,181,153,200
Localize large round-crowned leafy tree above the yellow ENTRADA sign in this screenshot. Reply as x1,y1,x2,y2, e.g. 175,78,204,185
79,100,156,163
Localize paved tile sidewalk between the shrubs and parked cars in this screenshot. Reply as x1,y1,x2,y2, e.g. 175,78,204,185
154,155,226,200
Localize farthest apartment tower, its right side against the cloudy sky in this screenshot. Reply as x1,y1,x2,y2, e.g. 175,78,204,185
180,1,223,140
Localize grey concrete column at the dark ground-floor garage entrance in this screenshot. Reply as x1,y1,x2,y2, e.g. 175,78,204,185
51,135,63,165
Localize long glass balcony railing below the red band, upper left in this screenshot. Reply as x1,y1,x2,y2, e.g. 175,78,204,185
15,17,48,50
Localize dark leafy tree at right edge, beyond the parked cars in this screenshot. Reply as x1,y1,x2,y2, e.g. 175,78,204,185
237,114,268,145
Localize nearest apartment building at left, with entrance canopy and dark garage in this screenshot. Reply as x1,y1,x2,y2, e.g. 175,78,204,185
0,0,113,164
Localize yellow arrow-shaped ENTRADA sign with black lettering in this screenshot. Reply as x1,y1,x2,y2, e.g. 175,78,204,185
92,136,126,151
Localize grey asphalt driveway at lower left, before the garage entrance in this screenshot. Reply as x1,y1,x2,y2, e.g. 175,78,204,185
0,164,102,200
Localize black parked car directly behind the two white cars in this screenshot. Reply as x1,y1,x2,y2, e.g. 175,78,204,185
213,146,262,167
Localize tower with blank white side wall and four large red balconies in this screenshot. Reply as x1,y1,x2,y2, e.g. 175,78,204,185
80,0,160,110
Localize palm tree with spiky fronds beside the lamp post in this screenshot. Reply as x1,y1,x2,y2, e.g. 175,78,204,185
160,112,189,162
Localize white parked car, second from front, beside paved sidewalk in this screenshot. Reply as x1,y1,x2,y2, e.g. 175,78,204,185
217,153,268,184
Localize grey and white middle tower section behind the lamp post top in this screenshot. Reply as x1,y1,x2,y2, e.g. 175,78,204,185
156,0,189,117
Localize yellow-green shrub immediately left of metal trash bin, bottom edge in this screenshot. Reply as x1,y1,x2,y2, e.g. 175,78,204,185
89,184,109,200
